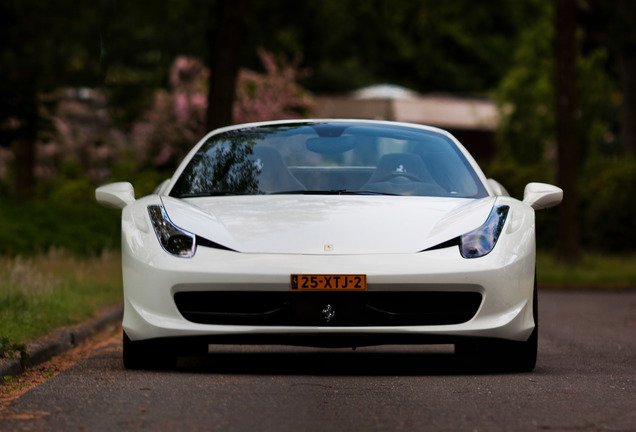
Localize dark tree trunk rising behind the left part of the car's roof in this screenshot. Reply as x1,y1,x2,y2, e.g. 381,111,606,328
207,0,248,130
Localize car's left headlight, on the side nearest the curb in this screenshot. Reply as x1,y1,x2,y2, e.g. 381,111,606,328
148,205,197,258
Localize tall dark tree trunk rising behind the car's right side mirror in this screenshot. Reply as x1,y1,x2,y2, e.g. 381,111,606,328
555,0,581,264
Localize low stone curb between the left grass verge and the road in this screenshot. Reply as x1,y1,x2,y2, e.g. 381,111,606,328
0,306,124,378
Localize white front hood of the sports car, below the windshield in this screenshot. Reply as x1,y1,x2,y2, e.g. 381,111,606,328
162,195,495,255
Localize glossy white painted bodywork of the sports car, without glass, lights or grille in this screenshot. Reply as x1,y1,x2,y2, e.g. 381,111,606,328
95,118,554,348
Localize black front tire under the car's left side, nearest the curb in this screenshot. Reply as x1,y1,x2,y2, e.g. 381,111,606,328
123,332,177,369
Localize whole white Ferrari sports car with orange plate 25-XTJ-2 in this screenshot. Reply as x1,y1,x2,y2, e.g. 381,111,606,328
96,120,563,371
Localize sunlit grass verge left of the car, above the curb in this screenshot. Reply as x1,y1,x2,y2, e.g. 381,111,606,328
0,250,122,342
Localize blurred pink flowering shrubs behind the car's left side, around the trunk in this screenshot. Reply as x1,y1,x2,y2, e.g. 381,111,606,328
0,50,311,184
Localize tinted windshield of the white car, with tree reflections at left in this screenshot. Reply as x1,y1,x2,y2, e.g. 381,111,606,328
170,122,488,198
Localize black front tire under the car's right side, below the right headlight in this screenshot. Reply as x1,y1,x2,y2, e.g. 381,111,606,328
455,275,539,372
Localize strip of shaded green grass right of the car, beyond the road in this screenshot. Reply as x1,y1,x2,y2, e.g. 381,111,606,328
537,252,636,289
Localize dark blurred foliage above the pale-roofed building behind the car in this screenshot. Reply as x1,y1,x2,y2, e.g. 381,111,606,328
245,0,537,93
